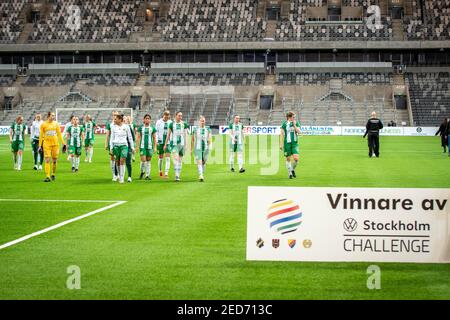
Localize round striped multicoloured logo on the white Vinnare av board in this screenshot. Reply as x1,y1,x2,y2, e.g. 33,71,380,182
267,199,303,234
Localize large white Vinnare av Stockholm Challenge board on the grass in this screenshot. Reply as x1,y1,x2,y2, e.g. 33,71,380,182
247,187,450,263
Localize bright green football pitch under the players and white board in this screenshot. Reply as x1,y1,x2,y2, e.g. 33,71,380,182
0,136,450,299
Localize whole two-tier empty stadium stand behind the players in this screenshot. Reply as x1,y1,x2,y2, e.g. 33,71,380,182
0,0,450,130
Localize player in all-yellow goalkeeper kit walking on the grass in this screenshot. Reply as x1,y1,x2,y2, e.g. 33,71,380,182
39,112,67,182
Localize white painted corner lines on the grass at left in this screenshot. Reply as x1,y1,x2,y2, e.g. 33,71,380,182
0,199,126,250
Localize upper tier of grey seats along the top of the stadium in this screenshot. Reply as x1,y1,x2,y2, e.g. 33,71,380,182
0,0,450,44
